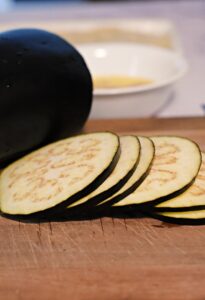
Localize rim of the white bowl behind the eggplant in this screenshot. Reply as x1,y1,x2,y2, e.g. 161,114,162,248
78,42,188,96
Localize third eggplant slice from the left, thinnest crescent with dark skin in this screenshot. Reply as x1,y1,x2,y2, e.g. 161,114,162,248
98,136,155,208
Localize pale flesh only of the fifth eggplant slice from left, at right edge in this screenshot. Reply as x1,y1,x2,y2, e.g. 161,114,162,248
156,153,205,208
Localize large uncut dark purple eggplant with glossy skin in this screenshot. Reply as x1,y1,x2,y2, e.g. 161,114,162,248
0,29,92,168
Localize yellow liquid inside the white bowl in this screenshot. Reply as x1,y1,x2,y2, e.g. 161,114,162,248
93,75,153,89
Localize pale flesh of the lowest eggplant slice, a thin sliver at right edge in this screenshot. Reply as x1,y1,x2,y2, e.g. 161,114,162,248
157,210,205,220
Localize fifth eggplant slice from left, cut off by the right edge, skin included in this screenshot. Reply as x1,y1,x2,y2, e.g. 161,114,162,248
153,152,205,212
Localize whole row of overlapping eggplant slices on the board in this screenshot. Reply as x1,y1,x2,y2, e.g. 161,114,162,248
0,132,205,224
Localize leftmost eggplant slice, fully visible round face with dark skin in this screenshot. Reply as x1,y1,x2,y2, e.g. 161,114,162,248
0,132,120,215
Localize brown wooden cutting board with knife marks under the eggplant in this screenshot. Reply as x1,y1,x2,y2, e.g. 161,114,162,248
0,118,205,300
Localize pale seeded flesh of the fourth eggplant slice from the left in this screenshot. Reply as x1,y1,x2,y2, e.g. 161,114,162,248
116,137,201,206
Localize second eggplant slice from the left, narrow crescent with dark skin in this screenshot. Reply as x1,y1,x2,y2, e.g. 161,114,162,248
67,136,140,213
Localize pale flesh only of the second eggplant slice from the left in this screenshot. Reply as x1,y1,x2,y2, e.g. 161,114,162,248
68,136,140,208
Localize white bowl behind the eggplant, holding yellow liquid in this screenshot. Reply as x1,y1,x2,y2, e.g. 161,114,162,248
78,43,187,118
